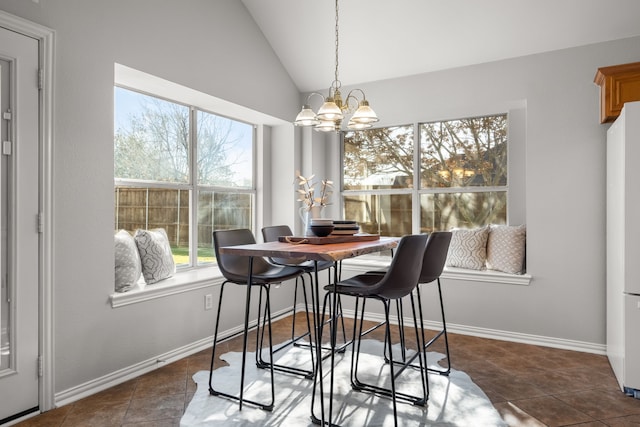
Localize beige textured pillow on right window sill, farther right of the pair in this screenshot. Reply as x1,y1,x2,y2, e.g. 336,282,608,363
487,225,527,274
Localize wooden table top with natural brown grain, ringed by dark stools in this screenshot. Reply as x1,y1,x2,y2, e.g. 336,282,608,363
220,237,400,261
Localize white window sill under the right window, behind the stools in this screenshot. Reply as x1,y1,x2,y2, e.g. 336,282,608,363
343,256,533,286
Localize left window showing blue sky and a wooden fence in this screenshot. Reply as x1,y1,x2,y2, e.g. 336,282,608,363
114,86,256,268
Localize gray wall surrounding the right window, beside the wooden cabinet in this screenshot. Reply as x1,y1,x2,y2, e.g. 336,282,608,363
345,38,640,347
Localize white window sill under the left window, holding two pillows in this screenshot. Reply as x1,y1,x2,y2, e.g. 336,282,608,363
110,267,224,308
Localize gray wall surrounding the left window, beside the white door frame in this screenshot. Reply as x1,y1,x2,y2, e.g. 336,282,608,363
0,0,299,392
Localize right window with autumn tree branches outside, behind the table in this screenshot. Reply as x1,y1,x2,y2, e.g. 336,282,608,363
343,114,508,236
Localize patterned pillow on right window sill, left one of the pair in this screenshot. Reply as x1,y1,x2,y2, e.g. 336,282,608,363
446,226,489,270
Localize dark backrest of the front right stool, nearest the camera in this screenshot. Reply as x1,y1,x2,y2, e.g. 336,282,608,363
375,234,429,299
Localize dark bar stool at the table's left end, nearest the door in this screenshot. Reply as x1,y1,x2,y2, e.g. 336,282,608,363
209,229,304,411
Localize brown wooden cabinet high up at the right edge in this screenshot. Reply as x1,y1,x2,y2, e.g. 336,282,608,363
594,62,640,123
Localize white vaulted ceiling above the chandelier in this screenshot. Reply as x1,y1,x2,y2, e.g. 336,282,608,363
242,0,640,92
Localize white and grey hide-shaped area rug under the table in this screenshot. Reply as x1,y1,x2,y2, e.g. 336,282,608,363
180,340,506,427
